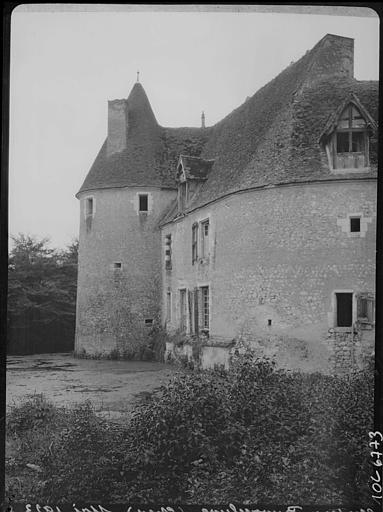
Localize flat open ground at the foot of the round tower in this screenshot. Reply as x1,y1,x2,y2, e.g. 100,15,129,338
7,353,174,420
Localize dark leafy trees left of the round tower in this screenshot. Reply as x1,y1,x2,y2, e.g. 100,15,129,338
8,234,78,349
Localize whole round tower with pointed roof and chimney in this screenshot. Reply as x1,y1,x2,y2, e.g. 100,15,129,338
75,82,176,357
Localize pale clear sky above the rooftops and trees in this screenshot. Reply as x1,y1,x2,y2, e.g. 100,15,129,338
9,4,379,248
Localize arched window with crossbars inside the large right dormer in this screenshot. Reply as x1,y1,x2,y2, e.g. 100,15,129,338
333,103,369,169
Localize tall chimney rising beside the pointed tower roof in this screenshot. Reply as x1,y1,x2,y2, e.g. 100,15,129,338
107,100,128,156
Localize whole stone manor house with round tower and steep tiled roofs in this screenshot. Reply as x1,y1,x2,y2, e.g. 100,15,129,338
75,34,378,372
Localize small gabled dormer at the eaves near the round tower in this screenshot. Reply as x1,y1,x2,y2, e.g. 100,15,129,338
176,155,214,212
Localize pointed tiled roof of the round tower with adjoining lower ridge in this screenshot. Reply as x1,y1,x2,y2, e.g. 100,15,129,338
79,83,210,193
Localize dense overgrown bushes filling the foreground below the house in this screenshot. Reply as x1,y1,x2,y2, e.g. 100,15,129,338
8,354,373,506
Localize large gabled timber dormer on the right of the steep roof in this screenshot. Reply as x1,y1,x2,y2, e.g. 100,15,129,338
320,94,377,173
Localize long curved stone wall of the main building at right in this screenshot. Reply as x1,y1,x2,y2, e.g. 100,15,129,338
162,180,376,370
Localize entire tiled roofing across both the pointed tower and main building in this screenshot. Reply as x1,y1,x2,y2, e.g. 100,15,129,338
77,35,378,222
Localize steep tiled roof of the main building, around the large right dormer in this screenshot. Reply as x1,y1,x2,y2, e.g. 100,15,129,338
167,36,378,220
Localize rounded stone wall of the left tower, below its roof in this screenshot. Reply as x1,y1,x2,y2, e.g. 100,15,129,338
75,187,175,355
